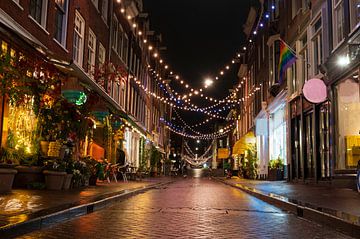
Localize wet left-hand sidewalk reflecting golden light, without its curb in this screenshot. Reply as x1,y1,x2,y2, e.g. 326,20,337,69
0,178,169,231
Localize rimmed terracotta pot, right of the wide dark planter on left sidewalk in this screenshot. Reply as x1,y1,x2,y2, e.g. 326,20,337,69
43,160,66,190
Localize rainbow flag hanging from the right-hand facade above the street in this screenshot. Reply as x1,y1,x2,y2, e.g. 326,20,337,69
278,39,297,84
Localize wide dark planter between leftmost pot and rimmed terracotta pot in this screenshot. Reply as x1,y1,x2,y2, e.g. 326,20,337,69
14,154,45,188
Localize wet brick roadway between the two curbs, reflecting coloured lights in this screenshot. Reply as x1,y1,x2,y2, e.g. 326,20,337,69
15,179,350,239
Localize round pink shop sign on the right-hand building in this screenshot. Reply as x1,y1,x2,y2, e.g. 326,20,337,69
302,78,327,104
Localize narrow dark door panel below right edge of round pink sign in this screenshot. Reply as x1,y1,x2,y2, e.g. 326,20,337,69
319,103,331,178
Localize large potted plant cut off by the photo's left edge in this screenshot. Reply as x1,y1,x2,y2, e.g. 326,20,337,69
0,148,18,192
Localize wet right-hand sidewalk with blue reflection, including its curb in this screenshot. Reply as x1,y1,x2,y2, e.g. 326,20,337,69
216,177,360,237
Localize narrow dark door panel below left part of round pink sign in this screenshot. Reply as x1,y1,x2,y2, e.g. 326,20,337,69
304,112,315,178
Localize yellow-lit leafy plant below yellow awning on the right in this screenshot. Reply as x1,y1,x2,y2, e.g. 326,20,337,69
240,144,257,179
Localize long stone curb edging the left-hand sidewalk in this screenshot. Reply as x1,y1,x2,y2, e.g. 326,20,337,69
0,181,174,238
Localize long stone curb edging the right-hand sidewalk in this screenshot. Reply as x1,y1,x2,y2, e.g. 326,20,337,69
213,178,360,238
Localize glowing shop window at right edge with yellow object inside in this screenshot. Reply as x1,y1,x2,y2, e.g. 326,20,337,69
336,72,360,169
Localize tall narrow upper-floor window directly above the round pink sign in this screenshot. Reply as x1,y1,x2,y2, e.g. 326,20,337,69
311,16,323,75
